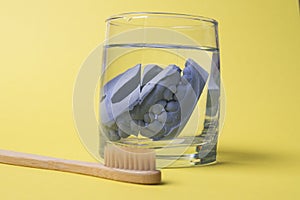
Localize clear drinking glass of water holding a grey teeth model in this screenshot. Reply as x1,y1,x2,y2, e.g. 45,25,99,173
99,13,220,168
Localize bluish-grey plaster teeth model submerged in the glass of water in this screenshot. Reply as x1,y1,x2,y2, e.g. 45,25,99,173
100,59,208,141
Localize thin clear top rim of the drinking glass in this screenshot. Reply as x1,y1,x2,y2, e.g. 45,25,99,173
105,12,218,25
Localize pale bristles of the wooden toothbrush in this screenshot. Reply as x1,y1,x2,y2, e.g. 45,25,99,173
104,144,155,171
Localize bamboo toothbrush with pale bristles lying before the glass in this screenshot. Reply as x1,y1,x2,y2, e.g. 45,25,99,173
0,144,161,184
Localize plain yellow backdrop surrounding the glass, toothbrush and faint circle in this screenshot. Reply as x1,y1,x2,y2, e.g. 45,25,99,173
0,0,300,200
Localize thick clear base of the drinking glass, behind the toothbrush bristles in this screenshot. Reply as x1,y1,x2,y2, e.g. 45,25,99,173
100,137,217,169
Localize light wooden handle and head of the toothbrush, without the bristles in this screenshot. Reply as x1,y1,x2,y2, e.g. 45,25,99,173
0,149,161,184
